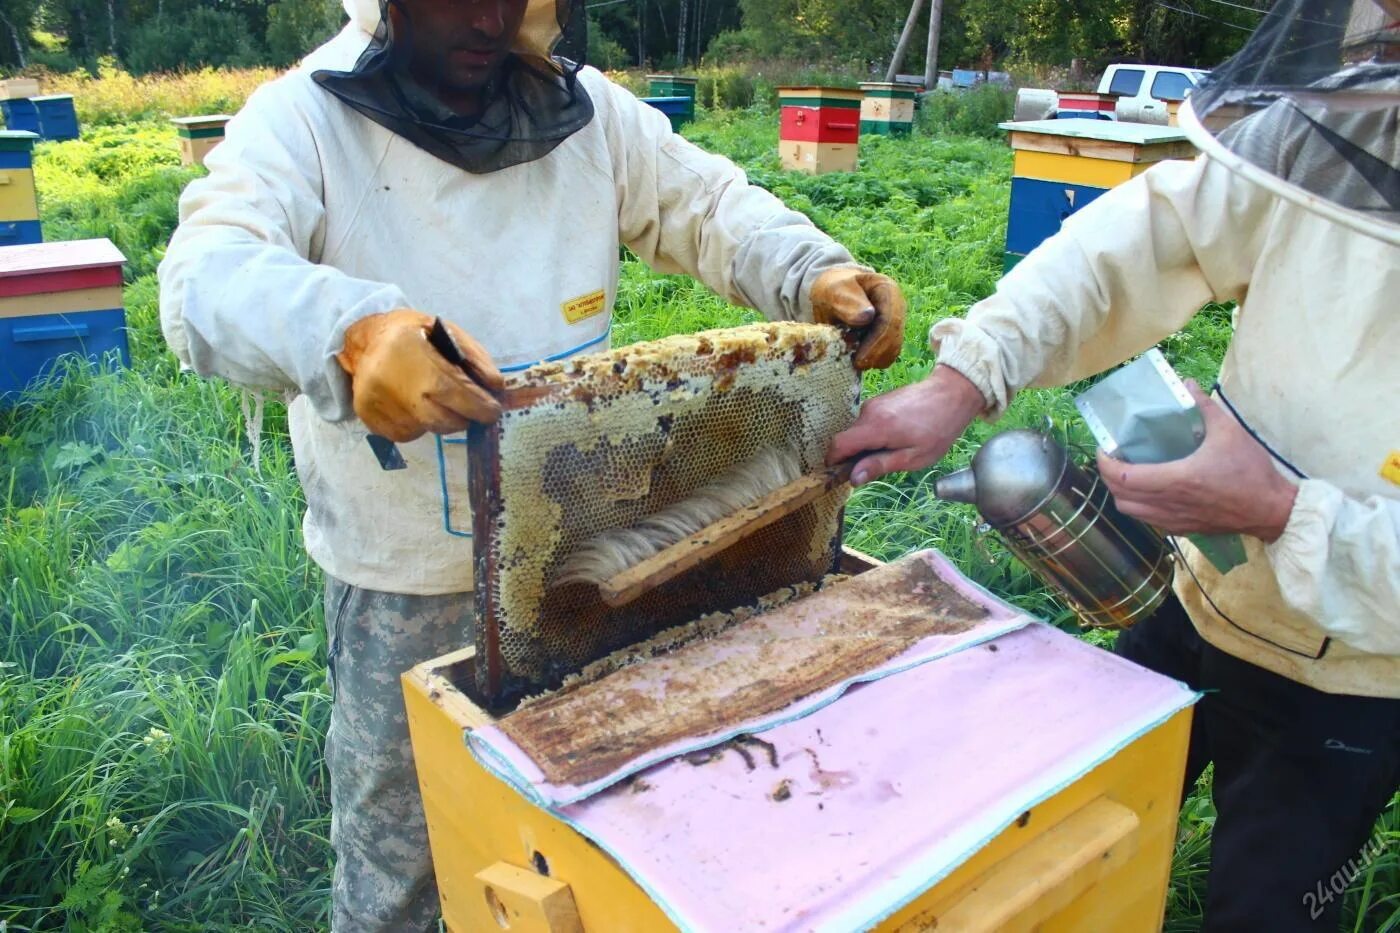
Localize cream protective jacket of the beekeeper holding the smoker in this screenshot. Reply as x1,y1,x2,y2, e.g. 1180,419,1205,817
931,0,1400,698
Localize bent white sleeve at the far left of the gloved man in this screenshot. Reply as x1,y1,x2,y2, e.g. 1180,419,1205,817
160,74,407,420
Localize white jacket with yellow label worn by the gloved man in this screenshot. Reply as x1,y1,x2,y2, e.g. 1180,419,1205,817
160,0,873,594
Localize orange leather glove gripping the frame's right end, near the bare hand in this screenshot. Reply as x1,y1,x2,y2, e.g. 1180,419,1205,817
812,266,904,370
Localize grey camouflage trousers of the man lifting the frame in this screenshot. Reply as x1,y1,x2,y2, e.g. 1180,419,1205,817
326,577,473,933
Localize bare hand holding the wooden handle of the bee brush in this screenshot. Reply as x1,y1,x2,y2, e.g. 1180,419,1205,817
826,366,987,486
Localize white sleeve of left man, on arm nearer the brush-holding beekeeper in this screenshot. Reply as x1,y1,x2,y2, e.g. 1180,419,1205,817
598,74,857,321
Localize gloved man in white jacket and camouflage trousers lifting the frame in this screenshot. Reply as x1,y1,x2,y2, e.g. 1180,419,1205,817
160,0,904,932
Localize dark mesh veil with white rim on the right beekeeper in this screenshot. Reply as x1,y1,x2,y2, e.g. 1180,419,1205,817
1182,0,1400,244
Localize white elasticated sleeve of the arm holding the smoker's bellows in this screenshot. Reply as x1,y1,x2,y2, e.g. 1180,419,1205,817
1266,479,1400,654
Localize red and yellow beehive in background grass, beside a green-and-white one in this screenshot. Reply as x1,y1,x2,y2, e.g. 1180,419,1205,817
778,87,862,175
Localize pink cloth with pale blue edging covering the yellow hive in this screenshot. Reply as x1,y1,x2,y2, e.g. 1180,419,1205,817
469,551,1197,932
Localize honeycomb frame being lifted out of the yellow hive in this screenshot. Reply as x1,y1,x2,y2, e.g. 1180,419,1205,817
469,322,860,706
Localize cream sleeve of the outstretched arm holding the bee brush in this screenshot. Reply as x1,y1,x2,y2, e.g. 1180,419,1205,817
930,158,1274,416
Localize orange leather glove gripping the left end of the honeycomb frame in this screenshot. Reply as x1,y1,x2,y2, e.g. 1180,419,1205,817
336,308,504,443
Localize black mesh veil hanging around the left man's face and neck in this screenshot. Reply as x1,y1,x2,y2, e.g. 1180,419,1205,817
312,0,594,174
